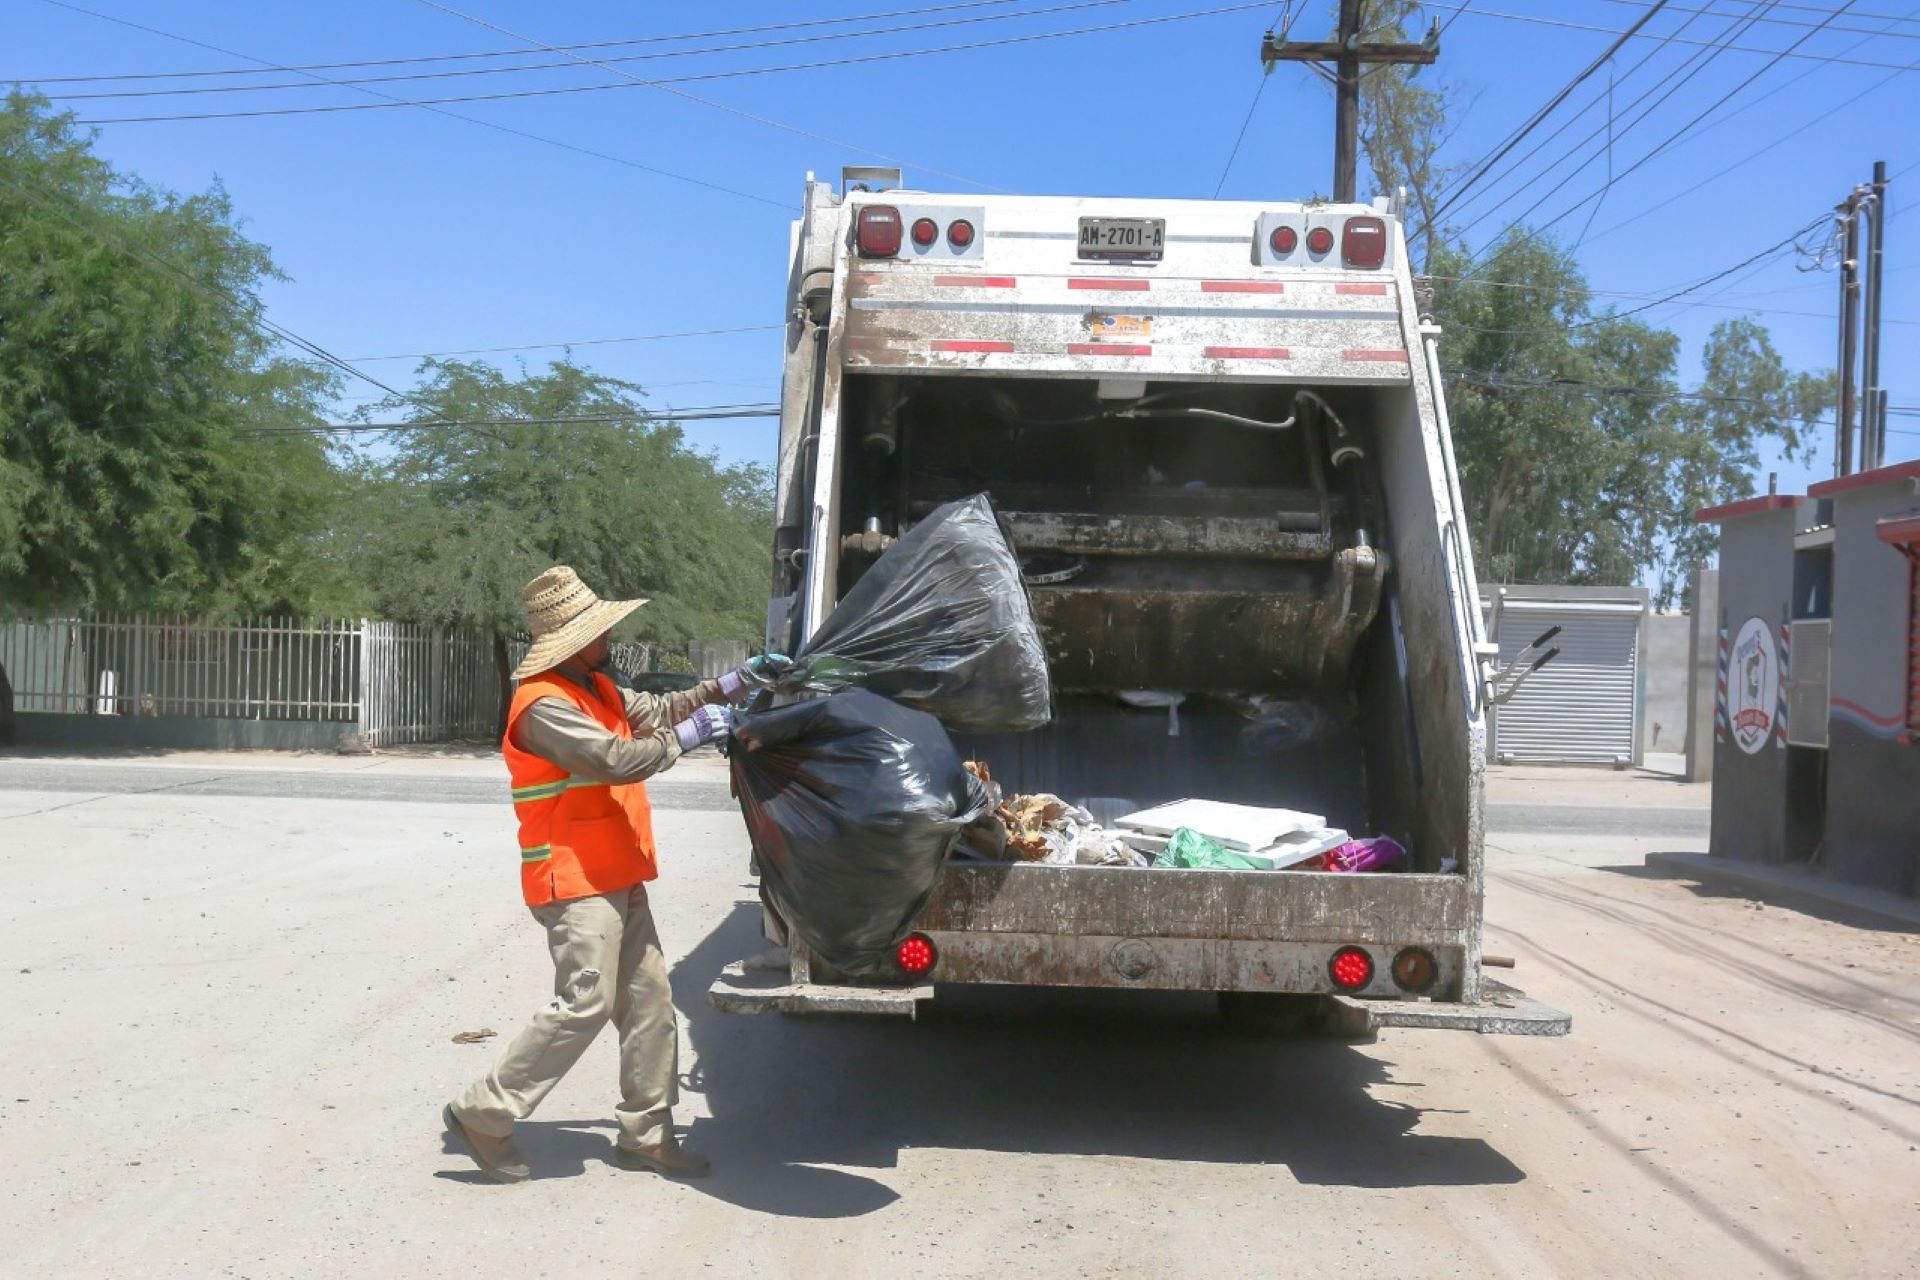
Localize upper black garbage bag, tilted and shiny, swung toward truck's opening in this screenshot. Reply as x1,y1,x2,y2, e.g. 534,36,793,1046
778,493,1054,733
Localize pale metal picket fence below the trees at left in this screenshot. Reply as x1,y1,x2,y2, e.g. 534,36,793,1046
0,616,499,747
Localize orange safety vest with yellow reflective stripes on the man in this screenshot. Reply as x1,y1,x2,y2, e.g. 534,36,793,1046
501,672,660,906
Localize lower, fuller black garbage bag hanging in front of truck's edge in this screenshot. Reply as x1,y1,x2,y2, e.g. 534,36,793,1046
730,689,989,977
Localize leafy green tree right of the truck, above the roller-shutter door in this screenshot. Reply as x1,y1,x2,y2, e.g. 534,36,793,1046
1434,234,1832,604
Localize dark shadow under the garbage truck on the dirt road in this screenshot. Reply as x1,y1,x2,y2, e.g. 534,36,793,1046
674,902,1526,1217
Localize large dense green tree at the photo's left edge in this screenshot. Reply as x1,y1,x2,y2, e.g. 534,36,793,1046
0,92,345,729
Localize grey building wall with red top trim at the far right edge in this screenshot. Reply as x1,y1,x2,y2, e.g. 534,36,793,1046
1816,478,1920,896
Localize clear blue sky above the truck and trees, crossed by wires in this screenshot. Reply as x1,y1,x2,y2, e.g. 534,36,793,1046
0,0,1920,489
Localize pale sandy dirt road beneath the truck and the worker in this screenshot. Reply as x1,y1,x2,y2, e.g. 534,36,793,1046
0,760,1920,1278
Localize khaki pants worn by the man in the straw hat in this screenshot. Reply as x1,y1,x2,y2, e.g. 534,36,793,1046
453,885,680,1148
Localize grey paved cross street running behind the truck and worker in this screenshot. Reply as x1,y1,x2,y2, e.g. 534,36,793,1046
0,760,1707,837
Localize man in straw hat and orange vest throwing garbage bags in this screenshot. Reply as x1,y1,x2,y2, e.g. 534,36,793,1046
442,566,791,1182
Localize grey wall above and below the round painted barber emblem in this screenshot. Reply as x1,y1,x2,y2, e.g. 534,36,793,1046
1709,499,1811,864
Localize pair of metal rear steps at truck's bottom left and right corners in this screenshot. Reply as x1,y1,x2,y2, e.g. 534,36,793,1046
707,963,1572,1036
